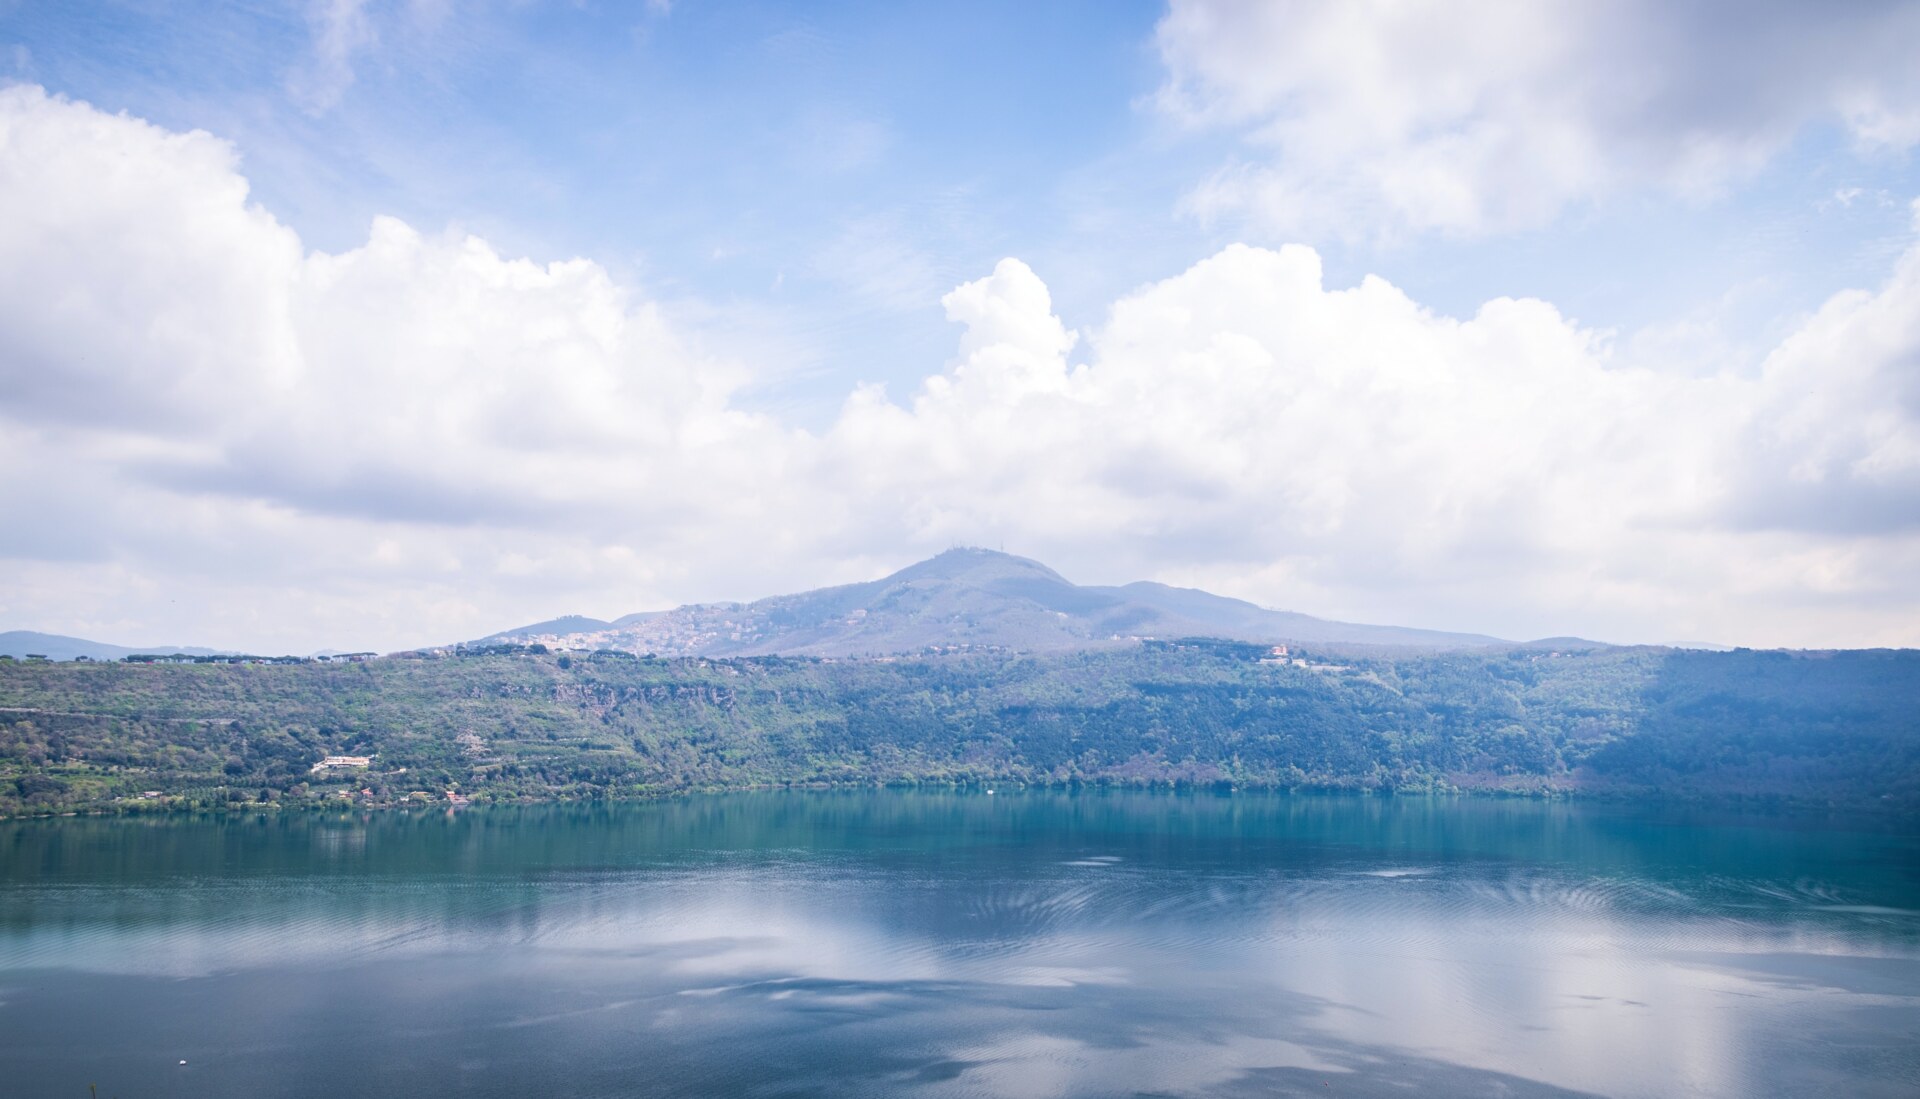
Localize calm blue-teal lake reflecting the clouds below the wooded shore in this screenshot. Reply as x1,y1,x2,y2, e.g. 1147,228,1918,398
0,792,1920,1099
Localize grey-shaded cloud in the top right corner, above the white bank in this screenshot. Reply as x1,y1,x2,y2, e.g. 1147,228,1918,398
1158,0,1920,238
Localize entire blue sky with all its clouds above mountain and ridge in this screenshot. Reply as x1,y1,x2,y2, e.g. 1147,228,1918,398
0,0,1920,653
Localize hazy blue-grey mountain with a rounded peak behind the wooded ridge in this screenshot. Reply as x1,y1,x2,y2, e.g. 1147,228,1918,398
482,550,1509,657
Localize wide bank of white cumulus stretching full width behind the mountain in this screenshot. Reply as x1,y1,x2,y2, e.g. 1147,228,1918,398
0,86,1920,647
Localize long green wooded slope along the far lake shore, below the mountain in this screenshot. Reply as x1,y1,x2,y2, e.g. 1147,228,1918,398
0,642,1920,815
